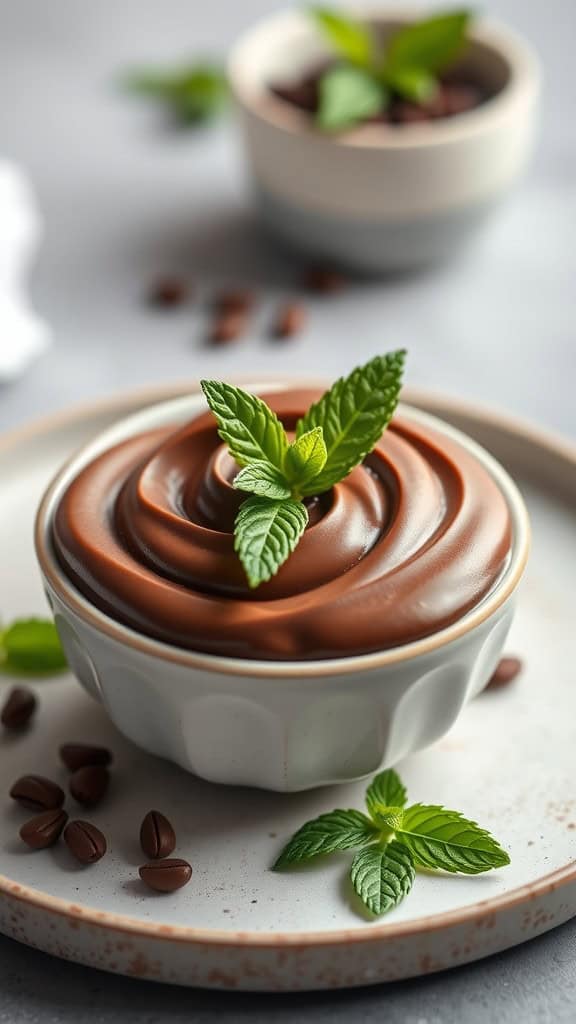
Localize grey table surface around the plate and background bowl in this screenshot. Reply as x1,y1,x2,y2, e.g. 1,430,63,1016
0,0,576,1024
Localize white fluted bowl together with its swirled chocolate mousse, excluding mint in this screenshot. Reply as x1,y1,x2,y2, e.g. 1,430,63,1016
36,383,530,792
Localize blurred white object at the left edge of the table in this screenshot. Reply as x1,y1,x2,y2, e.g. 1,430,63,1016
0,160,49,381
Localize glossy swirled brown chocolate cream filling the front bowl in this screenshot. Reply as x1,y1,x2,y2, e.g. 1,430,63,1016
53,390,510,660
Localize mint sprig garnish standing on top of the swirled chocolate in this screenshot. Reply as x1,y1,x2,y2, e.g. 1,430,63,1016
201,351,405,588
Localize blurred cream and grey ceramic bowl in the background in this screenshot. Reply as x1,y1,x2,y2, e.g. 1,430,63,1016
229,6,540,271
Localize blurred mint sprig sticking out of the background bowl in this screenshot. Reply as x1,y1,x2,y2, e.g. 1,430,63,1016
311,7,471,132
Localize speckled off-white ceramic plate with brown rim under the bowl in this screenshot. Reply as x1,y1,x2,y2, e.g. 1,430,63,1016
0,389,576,990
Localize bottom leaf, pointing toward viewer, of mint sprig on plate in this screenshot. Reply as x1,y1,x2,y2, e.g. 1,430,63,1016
351,841,415,916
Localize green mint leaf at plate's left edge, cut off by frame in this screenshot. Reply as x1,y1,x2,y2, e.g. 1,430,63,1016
0,618,67,674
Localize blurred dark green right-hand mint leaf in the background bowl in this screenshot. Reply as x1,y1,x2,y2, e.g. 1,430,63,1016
383,10,471,80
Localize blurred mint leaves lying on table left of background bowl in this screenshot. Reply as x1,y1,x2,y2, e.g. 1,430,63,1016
126,63,229,125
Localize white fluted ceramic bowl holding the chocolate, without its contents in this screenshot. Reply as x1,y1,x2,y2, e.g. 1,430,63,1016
36,384,529,792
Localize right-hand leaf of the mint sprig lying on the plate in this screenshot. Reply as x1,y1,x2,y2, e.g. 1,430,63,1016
398,804,510,874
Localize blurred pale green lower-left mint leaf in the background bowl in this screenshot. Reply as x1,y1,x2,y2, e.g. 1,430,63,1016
316,65,386,131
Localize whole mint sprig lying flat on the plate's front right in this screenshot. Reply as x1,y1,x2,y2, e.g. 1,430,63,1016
273,768,510,916
